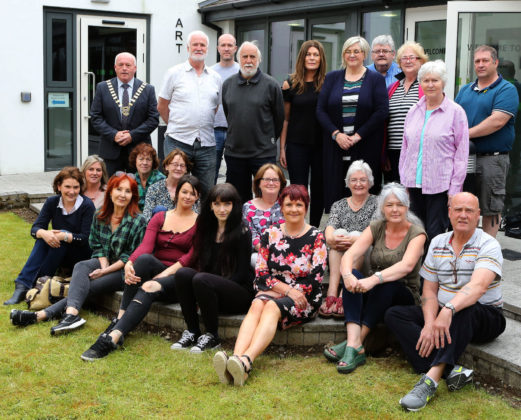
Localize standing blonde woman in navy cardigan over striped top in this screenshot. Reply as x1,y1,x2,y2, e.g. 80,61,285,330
317,36,389,212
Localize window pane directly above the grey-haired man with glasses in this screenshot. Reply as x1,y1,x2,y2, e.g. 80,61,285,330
362,9,403,55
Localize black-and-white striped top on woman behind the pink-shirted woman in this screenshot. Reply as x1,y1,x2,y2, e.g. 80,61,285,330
387,79,420,150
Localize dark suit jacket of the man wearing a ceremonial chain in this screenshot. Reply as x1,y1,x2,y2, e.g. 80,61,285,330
90,77,159,159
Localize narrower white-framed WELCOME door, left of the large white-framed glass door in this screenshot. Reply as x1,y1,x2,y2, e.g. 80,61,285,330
404,6,447,61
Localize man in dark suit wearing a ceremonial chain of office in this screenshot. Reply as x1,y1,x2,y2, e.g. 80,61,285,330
90,52,159,176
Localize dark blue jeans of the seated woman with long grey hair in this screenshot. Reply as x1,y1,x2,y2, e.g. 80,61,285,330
342,270,414,329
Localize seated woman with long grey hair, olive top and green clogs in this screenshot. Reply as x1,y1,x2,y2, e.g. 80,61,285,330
324,182,427,373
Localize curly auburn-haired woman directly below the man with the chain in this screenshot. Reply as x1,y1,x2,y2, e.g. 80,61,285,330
128,143,166,211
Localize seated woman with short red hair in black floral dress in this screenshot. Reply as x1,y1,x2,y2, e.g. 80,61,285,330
213,184,327,386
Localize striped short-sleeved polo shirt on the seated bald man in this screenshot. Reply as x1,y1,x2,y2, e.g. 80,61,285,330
420,229,503,307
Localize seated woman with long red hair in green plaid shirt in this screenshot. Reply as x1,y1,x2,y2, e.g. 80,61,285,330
11,172,146,335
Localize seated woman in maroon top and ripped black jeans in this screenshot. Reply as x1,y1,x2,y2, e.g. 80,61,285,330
81,175,201,361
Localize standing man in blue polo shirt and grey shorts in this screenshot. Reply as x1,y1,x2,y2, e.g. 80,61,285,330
456,45,519,237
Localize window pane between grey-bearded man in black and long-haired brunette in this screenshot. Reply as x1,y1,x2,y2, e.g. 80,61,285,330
269,19,304,83
